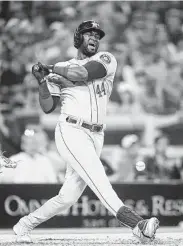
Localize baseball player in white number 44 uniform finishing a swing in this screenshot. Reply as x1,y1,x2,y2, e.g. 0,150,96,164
13,20,159,241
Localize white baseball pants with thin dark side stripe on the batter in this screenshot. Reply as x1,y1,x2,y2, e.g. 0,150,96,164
28,121,124,227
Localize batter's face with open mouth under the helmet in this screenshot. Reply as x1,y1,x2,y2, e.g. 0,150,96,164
80,31,100,56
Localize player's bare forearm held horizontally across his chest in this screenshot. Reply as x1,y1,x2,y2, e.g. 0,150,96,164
53,63,88,82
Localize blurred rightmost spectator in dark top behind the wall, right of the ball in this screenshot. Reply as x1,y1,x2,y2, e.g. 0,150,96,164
145,134,181,182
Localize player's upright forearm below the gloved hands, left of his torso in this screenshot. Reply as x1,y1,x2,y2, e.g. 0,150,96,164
39,82,54,113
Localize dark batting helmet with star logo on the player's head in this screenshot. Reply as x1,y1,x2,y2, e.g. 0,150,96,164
74,20,105,49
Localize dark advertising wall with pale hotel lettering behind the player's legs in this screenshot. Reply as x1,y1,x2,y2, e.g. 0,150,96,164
0,183,183,228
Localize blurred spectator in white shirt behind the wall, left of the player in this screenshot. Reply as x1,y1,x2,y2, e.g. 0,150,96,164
0,125,57,184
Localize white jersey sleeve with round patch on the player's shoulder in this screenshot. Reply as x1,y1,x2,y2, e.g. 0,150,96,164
92,52,117,97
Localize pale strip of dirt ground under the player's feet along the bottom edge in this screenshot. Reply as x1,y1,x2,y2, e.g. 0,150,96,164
0,228,183,246
